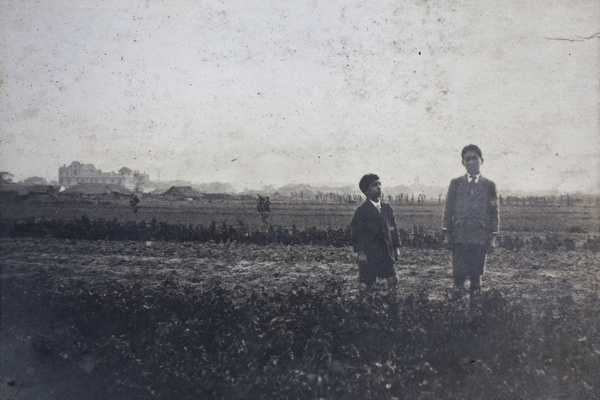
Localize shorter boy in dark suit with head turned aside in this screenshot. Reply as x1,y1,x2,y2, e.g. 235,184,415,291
351,174,400,294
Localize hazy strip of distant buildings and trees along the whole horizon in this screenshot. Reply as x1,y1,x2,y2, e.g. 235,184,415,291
0,161,599,206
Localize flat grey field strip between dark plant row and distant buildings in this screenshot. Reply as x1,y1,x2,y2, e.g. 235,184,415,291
0,200,600,234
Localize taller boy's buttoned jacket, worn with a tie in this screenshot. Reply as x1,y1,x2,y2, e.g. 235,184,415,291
442,175,499,245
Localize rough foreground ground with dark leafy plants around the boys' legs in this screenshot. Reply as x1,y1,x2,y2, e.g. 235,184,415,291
0,239,600,400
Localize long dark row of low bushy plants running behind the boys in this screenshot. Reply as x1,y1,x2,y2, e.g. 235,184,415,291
0,215,600,252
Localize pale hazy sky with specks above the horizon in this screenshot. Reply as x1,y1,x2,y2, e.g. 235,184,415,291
0,0,600,191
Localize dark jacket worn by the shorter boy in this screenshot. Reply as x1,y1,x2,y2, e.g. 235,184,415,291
350,199,400,265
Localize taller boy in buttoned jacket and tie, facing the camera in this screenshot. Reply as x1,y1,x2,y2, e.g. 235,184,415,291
442,145,499,298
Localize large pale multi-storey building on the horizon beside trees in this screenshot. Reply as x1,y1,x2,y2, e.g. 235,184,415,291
58,161,150,191
